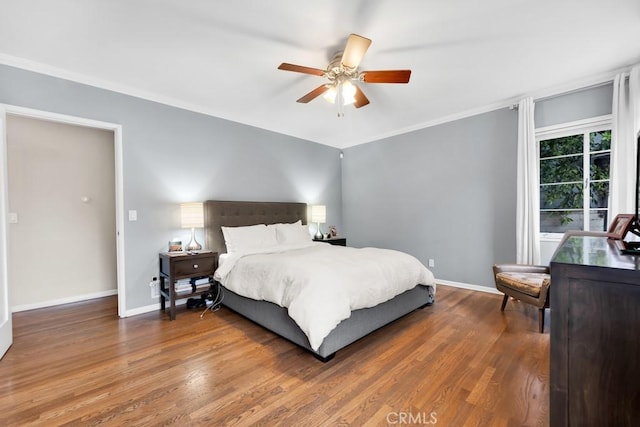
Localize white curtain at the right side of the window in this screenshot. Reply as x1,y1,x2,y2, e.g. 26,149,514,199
609,65,640,219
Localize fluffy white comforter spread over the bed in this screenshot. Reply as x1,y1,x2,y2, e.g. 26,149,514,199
214,242,435,350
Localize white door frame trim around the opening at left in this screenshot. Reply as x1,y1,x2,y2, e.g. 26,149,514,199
0,104,127,320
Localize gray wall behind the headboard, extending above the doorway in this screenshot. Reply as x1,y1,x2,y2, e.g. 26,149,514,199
0,65,342,310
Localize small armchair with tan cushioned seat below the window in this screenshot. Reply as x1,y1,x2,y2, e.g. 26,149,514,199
493,264,551,333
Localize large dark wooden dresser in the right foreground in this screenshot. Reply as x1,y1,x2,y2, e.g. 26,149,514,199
550,236,640,427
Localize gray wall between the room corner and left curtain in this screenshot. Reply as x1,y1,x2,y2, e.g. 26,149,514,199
342,108,518,286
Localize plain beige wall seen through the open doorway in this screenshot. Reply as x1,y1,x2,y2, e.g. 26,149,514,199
7,115,117,311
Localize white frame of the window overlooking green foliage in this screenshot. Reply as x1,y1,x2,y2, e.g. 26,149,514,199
535,114,613,242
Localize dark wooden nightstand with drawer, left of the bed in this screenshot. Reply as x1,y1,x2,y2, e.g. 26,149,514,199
160,251,218,320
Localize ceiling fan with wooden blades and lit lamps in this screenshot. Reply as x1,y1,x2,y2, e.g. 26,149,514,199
278,34,411,117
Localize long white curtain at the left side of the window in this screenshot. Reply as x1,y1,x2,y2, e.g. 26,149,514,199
516,98,540,264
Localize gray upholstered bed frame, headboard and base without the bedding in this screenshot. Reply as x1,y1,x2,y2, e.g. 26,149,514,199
204,200,435,362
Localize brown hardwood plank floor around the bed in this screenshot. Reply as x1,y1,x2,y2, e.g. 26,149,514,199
0,286,549,426
